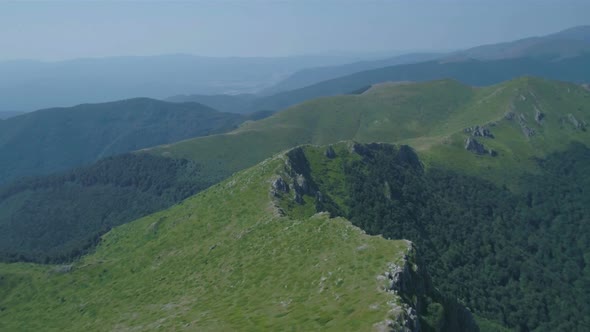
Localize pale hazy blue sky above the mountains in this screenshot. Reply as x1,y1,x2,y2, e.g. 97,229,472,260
0,0,590,60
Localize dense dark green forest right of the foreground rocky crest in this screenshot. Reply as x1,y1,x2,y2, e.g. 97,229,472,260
292,144,590,331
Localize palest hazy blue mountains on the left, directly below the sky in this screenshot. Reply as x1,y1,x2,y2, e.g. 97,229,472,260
0,55,382,111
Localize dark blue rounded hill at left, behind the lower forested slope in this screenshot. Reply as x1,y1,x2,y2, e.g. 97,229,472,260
0,98,265,183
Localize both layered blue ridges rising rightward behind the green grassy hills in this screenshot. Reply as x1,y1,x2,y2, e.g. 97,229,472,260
172,26,590,113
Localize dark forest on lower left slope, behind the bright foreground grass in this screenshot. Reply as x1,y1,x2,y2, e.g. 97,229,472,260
0,154,215,263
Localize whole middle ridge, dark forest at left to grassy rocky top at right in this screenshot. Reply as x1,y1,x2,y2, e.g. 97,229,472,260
0,78,590,262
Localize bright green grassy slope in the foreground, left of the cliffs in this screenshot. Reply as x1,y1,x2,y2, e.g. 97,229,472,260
0,152,407,331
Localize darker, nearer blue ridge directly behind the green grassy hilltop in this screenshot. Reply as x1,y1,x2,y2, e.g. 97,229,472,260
169,55,590,113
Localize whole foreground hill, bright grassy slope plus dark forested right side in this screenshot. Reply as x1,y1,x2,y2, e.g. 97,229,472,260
0,142,590,331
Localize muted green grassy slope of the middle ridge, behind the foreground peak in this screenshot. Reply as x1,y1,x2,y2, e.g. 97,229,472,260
149,78,590,188
